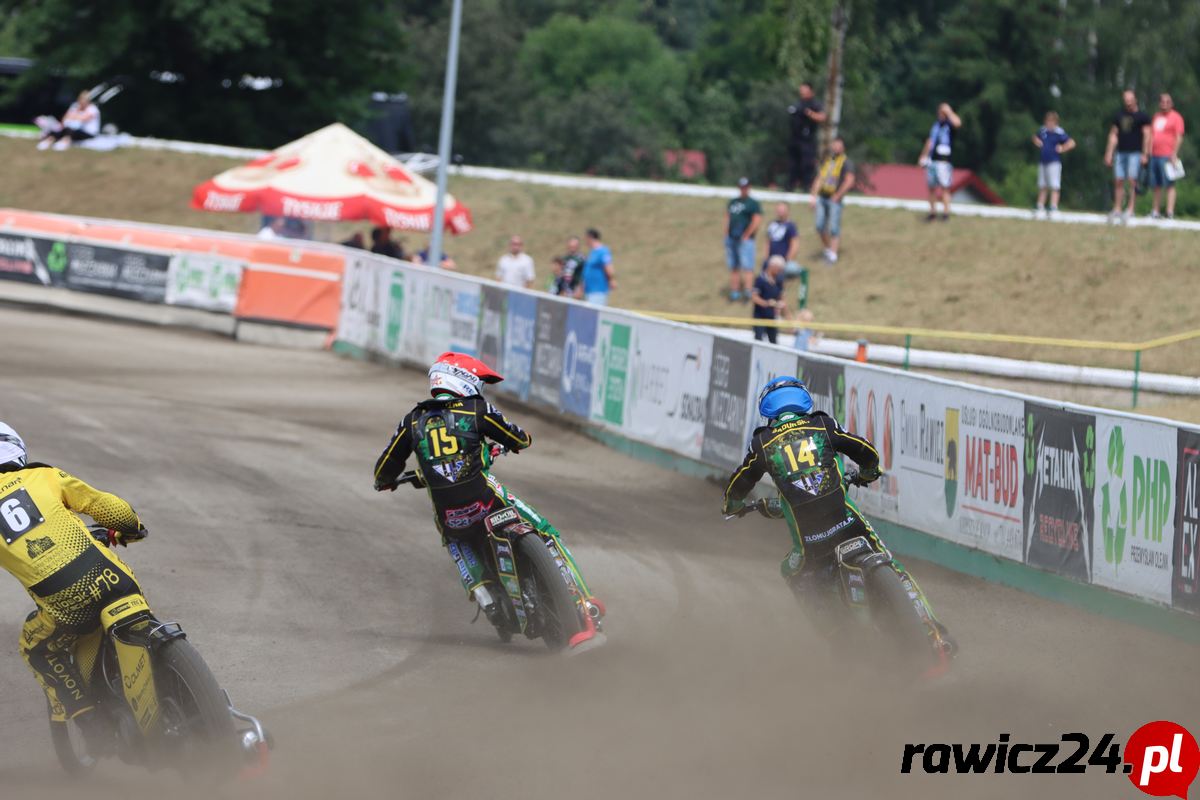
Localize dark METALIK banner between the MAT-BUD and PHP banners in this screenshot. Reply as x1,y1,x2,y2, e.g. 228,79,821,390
1022,402,1096,583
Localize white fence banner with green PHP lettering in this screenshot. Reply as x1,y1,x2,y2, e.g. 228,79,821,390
1092,415,1177,603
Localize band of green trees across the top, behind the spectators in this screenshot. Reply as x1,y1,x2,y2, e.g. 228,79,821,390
0,0,1200,213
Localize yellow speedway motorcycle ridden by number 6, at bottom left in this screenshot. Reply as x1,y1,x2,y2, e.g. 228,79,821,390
50,527,272,777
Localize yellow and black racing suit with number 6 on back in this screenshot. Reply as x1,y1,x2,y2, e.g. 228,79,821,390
0,464,142,722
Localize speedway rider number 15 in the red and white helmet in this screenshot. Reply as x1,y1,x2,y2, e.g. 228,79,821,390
374,353,602,633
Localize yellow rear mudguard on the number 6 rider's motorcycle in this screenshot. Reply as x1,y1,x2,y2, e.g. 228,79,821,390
101,595,185,734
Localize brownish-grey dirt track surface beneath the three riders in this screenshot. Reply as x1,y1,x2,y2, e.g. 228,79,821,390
0,303,1200,800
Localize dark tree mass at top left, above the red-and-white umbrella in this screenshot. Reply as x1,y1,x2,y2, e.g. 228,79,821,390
0,0,404,146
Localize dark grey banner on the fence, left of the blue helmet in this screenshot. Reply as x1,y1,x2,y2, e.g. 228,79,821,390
701,338,752,469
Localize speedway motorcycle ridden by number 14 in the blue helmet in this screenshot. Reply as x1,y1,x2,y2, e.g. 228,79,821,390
725,471,953,678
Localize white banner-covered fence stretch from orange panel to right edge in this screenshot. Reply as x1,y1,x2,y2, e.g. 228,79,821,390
334,254,1200,614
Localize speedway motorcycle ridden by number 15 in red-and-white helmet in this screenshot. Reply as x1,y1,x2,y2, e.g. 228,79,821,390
396,445,605,654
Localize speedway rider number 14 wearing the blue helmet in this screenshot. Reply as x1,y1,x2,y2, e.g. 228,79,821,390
725,377,949,642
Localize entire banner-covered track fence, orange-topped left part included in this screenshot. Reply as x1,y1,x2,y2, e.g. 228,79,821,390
7,209,1200,628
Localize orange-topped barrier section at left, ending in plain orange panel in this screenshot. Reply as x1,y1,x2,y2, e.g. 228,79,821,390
0,209,346,331
